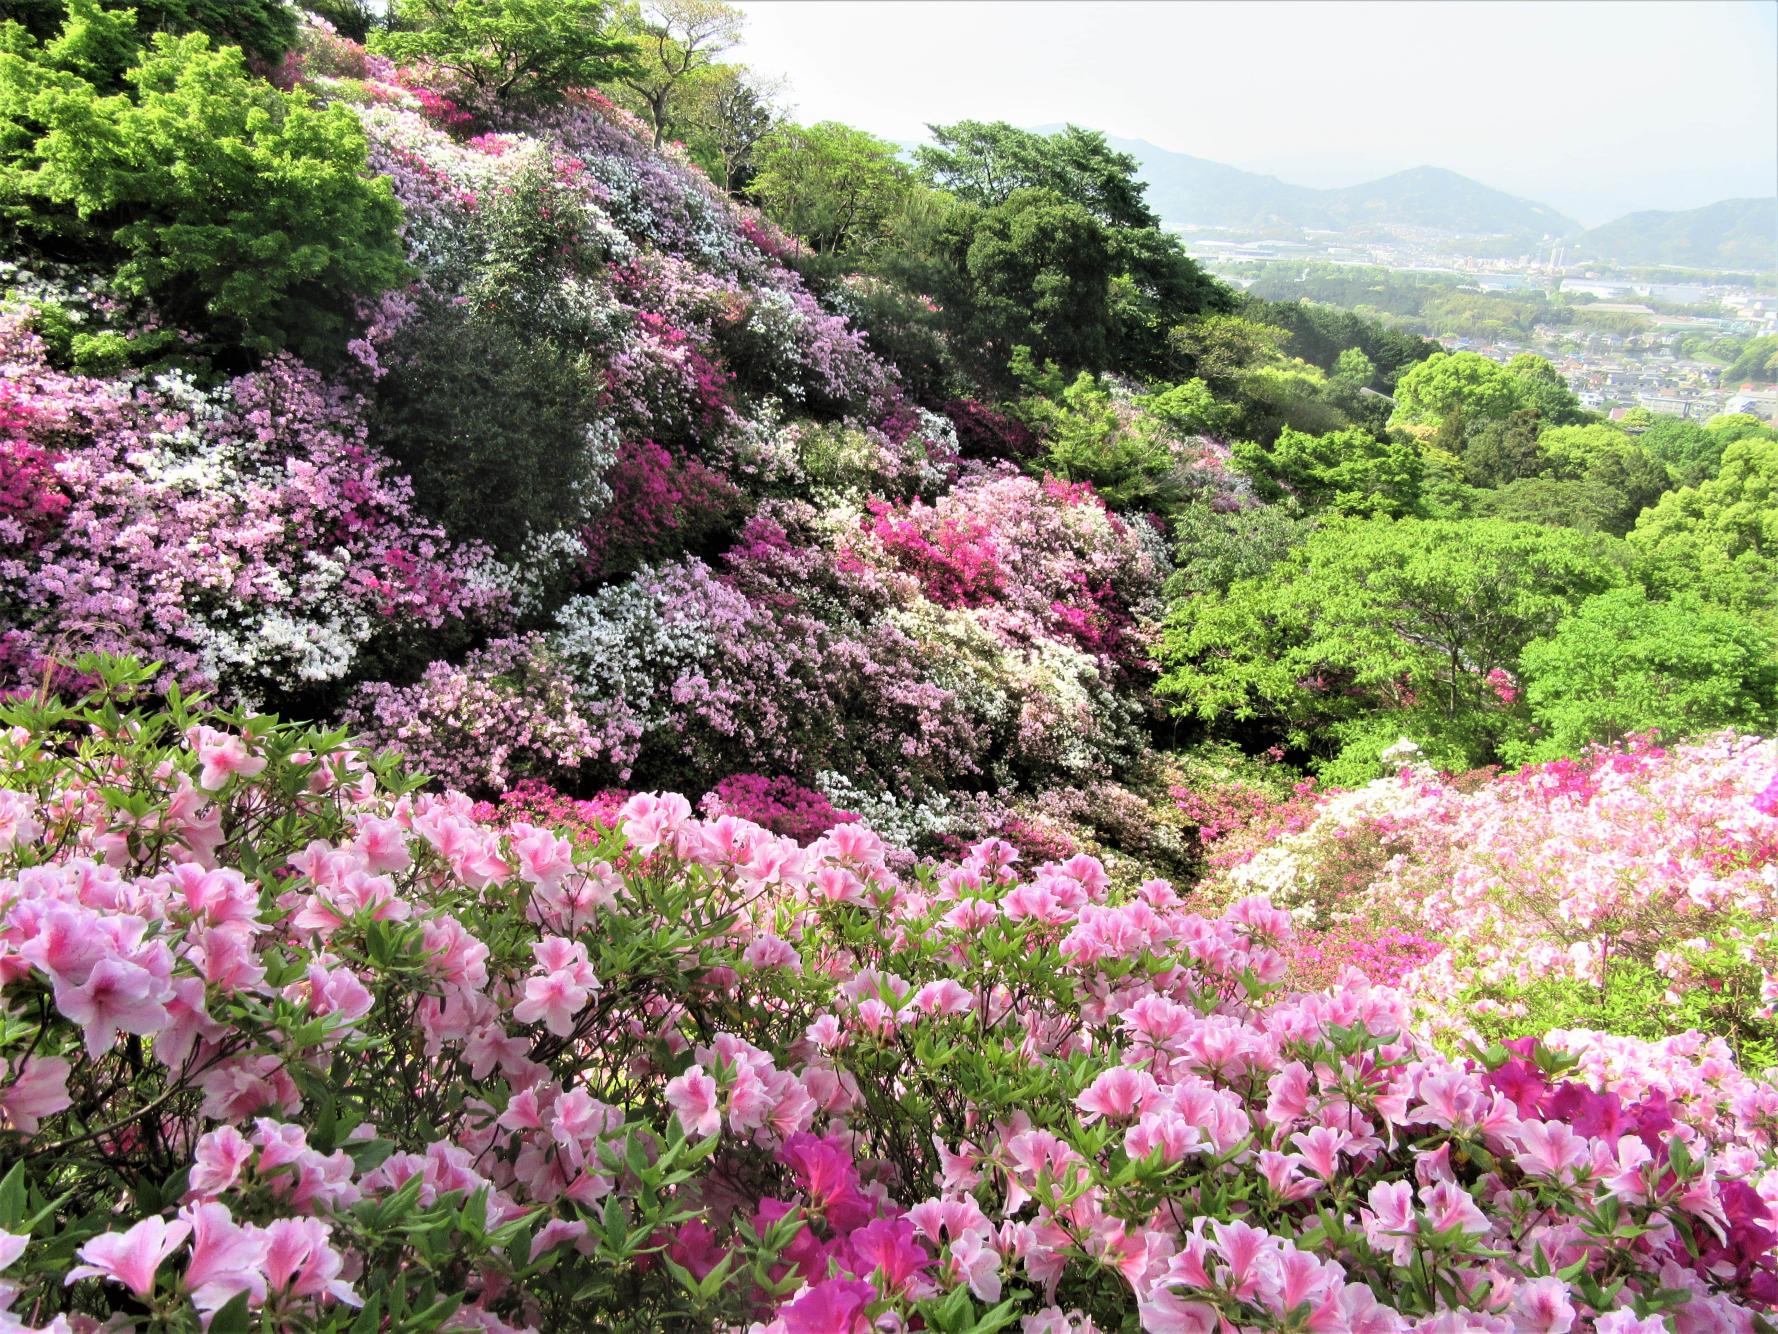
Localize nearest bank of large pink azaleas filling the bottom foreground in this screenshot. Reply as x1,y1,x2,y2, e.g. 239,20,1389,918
0,660,1778,1334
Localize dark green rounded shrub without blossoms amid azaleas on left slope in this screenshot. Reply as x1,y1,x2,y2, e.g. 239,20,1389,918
372,304,597,555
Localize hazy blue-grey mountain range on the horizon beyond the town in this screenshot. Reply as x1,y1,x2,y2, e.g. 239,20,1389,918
1042,126,1778,270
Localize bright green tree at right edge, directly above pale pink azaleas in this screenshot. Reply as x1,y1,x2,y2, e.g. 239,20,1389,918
1520,583,1778,759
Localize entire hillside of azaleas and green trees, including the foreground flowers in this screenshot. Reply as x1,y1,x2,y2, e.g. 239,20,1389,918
0,0,1778,1334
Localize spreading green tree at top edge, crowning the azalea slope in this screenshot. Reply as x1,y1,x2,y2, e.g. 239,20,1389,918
370,0,637,103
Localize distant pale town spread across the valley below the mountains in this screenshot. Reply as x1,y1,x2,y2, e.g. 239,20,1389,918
1179,228,1778,422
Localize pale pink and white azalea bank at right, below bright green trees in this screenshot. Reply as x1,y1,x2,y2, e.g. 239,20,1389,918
1181,733,1778,1067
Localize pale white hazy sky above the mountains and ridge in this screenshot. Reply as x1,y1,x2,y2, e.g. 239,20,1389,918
738,0,1778,226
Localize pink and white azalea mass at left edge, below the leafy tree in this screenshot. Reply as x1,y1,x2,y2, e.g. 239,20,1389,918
0,311,507,697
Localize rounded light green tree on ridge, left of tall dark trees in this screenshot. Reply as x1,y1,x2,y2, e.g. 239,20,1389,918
749,121,914,254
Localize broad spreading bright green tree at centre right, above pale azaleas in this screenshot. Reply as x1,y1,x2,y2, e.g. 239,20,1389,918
1161,519,1625,781
